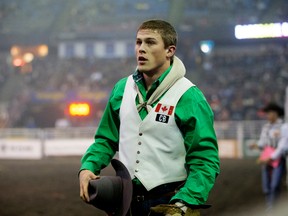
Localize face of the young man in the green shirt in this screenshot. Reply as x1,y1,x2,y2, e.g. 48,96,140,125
135,29,175,76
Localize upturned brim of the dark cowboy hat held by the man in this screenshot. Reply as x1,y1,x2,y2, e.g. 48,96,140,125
111,159,133,216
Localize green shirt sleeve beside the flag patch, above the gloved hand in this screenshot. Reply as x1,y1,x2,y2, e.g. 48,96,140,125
172,87,220,205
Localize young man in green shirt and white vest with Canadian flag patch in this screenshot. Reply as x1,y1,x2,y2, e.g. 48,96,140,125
79,20,219,216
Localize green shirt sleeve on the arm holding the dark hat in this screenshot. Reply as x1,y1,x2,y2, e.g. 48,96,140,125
80,78,127,174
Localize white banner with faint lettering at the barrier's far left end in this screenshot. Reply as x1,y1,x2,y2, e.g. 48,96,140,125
0,138,43,159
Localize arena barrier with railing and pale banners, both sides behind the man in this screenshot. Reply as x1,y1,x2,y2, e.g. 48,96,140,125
0,121,265,158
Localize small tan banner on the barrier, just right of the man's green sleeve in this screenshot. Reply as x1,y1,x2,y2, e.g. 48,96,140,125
218,139,241,158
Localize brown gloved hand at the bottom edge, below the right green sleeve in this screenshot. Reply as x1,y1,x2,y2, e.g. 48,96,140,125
151,204,200,216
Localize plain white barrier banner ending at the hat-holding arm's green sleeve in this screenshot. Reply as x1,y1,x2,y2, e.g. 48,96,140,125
44,138,94,156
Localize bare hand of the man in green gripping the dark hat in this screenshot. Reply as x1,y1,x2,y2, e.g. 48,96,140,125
79,170,100,202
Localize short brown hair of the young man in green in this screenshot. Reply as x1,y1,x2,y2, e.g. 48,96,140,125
137,20,177,48
